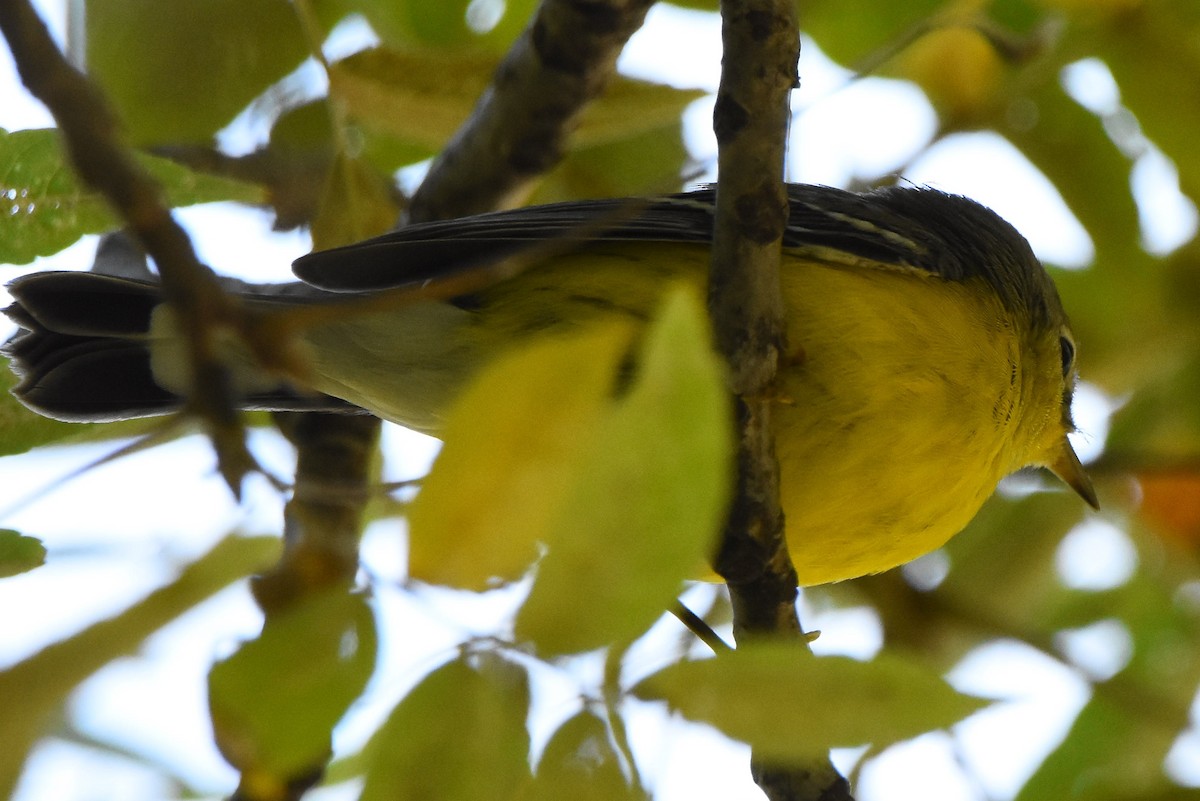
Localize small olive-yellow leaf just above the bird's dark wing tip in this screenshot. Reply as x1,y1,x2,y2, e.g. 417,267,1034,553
312,155,400,251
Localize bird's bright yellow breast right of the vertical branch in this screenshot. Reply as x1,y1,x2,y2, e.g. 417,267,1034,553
774,264,1024,584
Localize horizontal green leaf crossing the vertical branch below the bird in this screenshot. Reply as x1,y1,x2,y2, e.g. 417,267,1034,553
634,642,986,761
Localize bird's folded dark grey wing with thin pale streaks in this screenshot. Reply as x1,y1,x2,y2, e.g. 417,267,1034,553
293,183,1040,316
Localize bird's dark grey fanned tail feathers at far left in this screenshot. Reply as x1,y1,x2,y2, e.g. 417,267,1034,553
2,272,354,422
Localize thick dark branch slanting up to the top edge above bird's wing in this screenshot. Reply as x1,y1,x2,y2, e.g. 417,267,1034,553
408,0,654,222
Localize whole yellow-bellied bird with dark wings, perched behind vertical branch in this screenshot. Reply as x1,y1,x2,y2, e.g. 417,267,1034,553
7,185,1096,584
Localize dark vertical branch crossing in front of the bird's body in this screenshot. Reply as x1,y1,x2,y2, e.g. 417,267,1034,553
708,0,850,801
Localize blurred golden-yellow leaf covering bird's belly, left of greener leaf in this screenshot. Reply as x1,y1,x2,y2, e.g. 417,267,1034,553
409,321,632,590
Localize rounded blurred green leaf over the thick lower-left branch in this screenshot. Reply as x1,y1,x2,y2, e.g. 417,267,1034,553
209,588,376,782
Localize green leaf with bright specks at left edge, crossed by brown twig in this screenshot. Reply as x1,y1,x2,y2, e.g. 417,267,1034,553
0,130,263,264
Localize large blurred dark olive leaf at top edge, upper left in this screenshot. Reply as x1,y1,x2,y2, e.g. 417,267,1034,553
86,0,308,145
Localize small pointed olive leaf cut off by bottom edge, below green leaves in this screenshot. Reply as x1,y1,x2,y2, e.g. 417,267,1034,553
524,711,648,801
